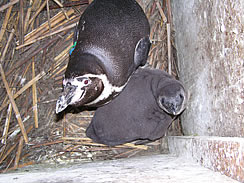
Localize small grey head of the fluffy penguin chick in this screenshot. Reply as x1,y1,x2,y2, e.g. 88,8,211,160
158,82,187,116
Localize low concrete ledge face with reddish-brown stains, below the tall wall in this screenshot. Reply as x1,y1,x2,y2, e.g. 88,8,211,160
168,136,244,183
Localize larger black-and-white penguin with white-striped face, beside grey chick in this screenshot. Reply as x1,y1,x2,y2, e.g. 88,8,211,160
56,0,151,113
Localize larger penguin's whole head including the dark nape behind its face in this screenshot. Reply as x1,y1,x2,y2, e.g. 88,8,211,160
56,51,108,113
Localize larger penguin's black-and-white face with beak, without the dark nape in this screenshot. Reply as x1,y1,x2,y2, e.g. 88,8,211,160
56,75,104,113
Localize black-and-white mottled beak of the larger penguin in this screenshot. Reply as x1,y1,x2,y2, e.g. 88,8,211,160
56,85,85,114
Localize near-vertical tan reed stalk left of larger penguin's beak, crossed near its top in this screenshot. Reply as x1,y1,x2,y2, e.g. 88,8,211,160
32,57,38,128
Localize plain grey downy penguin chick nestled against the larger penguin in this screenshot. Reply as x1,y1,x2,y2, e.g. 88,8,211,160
86,68,187,146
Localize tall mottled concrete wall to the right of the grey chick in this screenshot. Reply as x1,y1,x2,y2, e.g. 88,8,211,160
171,0,244,136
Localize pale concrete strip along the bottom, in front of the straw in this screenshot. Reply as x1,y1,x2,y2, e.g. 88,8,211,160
0,155,237,183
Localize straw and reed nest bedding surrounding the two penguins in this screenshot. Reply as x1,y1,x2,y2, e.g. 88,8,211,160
0,0,181,172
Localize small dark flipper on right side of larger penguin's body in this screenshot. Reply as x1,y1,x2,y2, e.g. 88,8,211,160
134,36,151,67
